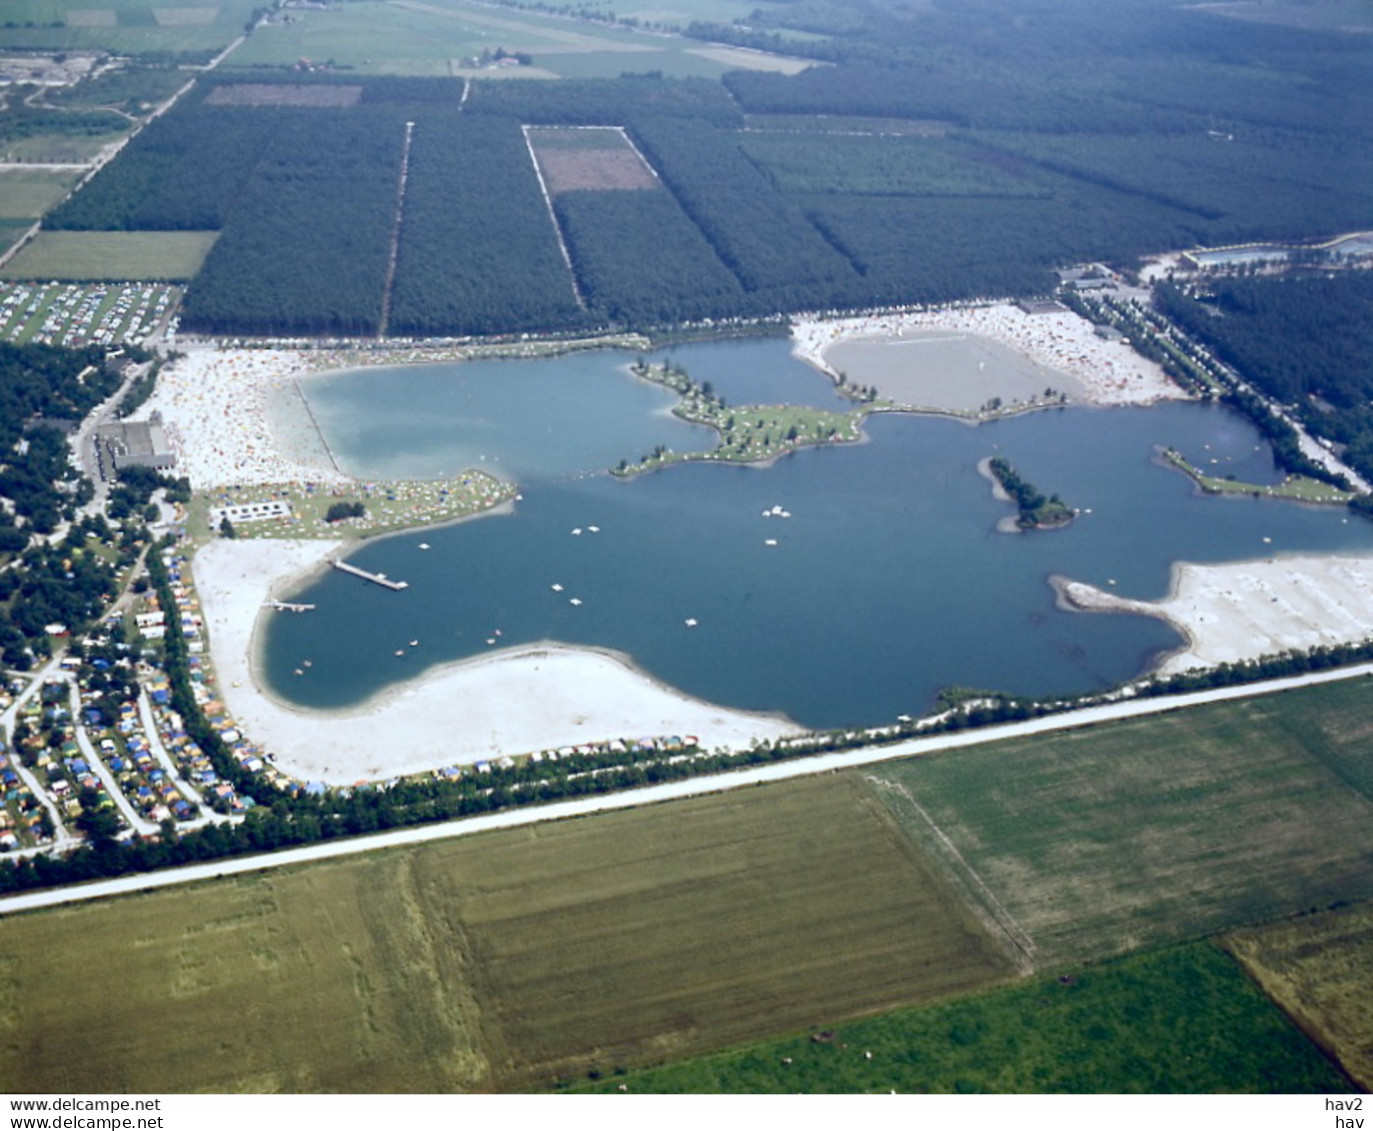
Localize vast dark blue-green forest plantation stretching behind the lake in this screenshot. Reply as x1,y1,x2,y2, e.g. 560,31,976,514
29,0,1373,335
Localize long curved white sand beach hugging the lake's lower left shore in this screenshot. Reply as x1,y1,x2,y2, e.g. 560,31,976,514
192,539,800,784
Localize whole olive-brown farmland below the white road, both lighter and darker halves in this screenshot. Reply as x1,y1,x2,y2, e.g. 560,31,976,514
0,777,1012,1091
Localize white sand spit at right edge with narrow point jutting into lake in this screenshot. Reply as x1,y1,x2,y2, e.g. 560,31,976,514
1054,556,1373,674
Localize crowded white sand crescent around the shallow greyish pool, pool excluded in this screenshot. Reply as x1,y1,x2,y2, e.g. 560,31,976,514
792,303,1185,405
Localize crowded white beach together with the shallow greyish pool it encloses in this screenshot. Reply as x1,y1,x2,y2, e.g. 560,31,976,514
792,303,1186,412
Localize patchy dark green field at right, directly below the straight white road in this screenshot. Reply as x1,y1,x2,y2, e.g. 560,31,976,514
869,684,1373,968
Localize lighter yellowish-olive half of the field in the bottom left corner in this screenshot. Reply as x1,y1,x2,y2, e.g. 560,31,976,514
0,854,486,1093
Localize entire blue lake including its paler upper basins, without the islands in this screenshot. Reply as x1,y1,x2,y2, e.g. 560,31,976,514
259,339,1373,727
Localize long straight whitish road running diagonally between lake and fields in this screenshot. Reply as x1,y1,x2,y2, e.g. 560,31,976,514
0,664,1373,916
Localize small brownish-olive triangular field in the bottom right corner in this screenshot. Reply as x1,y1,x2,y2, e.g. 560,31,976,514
1223,903,1373,1091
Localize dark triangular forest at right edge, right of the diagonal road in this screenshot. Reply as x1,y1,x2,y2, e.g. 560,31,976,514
1155,272,1373,478
